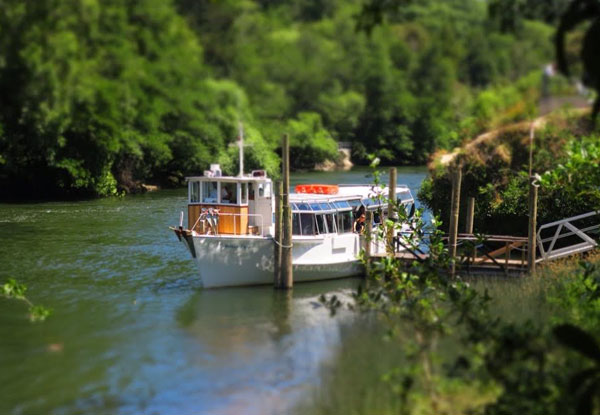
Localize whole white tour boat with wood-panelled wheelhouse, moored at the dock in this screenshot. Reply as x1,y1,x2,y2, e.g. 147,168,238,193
172,165,414,288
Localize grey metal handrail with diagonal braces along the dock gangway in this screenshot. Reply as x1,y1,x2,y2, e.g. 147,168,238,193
537,211,600,261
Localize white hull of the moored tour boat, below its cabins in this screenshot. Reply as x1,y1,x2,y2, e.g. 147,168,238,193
186,234,363,288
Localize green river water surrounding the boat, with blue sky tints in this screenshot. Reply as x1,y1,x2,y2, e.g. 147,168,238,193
0,168,425,415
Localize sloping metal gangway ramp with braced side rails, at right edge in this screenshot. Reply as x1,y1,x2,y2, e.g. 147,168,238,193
536,211,600,262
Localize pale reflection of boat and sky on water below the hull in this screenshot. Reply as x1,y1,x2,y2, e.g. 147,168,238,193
171,279,360,414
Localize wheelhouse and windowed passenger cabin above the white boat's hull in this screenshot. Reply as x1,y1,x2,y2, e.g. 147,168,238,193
187,165,414,236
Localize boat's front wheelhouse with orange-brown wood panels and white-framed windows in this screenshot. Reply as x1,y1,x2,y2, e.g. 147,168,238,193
186,165,272,236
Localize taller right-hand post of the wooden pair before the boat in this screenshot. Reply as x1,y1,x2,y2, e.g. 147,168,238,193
281,134,294,289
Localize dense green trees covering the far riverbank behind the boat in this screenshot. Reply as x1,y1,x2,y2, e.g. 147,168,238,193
0,0,553,198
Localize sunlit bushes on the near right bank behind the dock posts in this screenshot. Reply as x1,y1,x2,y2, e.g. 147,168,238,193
419,114,600,235
